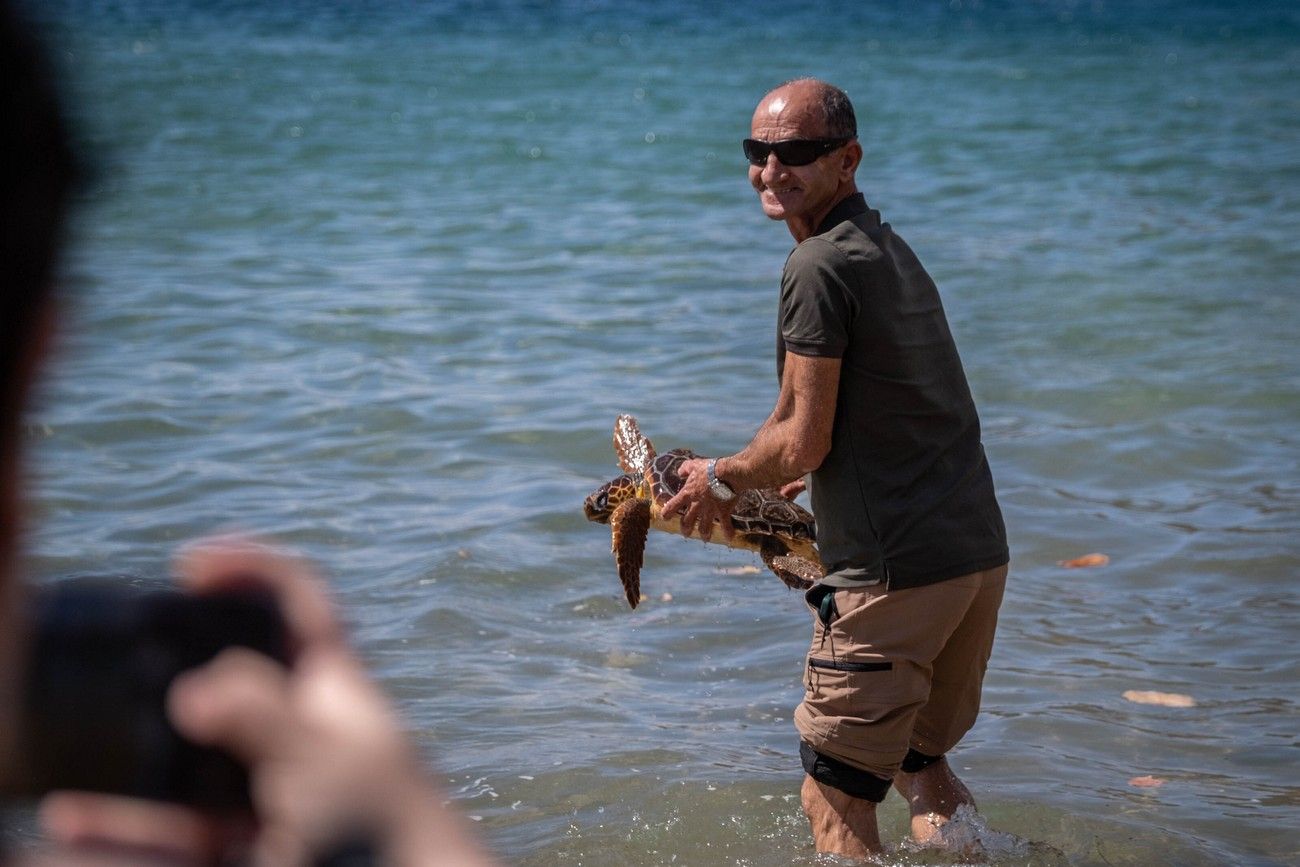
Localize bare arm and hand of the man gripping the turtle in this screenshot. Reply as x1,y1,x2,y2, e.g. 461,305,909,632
664,352,840,539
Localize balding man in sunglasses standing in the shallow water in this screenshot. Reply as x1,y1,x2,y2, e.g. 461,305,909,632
666,79,1008,857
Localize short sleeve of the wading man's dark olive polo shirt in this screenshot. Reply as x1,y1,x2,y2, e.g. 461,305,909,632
780,238,855,357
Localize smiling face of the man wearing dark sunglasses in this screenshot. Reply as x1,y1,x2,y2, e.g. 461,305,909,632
749,87,852,227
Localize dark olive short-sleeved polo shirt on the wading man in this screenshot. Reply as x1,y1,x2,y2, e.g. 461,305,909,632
777,195,1009,589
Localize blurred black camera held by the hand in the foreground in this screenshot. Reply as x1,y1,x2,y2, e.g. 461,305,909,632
7,577,287,811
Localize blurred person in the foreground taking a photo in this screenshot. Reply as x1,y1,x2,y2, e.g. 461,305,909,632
0,0,491,867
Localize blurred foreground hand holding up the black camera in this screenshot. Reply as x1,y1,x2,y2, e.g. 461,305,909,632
35,537,494,867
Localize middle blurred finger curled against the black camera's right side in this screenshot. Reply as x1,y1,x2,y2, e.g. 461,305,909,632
168,647,294,764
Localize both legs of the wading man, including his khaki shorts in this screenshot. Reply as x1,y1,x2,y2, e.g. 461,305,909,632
794,568,1005,858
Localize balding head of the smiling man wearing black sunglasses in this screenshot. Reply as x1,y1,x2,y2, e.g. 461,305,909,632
745,78,862,240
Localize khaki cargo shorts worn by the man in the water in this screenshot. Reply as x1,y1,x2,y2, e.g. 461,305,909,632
794,565,1008,785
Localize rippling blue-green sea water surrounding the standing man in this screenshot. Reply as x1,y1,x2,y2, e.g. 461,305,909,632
12,0,1300,867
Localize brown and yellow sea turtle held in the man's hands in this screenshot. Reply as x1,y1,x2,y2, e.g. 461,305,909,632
582,415,823,608
